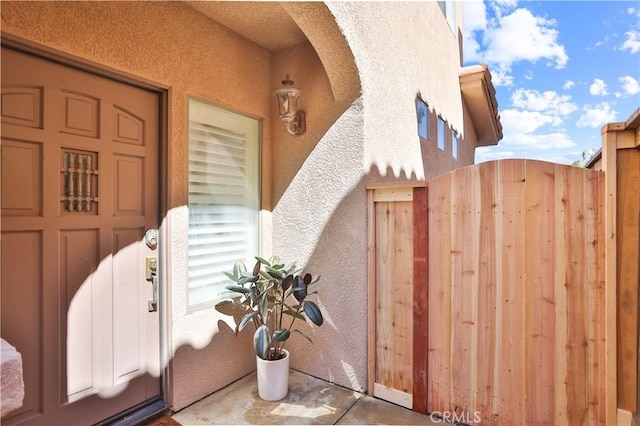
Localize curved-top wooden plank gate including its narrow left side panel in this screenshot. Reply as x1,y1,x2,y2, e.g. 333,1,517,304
369,160,606,424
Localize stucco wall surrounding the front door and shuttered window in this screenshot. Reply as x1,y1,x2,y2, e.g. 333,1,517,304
2,2,274,408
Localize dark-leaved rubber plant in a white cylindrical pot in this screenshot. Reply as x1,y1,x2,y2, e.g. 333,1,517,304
216,256,323,401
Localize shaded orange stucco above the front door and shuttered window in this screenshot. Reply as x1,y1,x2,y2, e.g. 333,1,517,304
2,1,273,207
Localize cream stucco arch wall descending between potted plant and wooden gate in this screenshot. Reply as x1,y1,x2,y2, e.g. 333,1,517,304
273,2,474,390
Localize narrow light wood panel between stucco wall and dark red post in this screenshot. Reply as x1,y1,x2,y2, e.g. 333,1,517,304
371,190,414,408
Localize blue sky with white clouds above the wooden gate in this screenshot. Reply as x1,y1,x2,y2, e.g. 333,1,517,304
462,0,640,164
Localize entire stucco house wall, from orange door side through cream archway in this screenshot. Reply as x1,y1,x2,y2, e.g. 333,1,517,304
2,2,475,410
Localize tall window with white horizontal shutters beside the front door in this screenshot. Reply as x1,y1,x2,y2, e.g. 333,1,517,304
188,100,260,308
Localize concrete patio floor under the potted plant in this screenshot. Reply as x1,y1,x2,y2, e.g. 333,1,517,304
172,370,438,426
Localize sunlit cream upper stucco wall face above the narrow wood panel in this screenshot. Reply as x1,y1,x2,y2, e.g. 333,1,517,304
328,2,464,179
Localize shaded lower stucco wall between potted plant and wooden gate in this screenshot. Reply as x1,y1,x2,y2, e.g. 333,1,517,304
277,165,417,392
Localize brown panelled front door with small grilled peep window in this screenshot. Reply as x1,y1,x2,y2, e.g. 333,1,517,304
0,48,160,425
